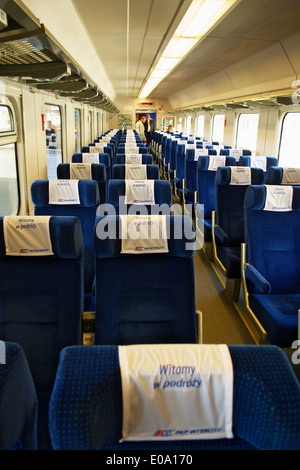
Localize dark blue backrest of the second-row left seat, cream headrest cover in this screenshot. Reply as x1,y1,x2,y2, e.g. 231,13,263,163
0,216,84,448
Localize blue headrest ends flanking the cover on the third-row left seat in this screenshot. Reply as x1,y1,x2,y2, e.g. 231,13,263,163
31,180,100,207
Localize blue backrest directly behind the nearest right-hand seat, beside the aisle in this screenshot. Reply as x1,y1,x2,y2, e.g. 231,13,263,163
215,166,264,246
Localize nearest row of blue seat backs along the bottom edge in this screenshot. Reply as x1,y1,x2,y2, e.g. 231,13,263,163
0,342,300,450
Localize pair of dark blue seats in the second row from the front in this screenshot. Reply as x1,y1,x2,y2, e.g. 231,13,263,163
0,215,198,448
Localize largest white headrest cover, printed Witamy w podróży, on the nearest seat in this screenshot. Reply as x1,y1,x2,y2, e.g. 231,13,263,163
119,344,233,440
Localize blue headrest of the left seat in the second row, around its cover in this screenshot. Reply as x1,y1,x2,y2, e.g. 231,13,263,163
0,216,84,258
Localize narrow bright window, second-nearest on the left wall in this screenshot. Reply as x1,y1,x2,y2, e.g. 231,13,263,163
45,104,62,180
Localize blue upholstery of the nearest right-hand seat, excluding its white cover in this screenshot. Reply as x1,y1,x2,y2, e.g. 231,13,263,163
244,186,300,347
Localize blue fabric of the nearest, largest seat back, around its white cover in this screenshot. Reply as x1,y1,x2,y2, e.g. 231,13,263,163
49,345,300,452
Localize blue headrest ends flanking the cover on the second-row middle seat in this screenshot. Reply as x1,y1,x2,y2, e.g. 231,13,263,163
94,215,195,258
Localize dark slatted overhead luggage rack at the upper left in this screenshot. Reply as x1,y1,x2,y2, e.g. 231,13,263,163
0,5,118,113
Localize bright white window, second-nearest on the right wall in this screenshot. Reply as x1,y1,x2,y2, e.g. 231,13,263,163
236,113,259,152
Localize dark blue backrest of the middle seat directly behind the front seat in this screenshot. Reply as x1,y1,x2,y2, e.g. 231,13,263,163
95,215,197,344
